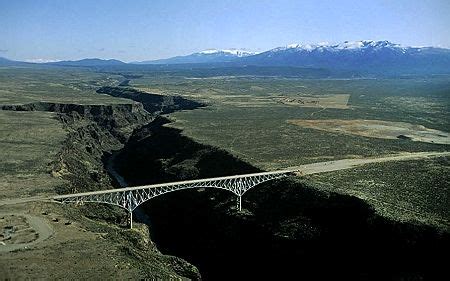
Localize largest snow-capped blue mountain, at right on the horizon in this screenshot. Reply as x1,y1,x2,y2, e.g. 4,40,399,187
240,40,450,73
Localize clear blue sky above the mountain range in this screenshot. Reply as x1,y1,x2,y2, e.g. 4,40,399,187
0,0,450,62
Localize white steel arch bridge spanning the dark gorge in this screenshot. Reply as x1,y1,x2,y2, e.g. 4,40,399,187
53,170,297,227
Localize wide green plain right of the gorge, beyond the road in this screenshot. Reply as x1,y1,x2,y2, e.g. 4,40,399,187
124,76,450,169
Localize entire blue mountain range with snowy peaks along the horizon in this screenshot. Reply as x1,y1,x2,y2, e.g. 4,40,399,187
0,40,450,75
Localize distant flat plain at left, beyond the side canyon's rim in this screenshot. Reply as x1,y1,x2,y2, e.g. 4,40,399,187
0,66,129,105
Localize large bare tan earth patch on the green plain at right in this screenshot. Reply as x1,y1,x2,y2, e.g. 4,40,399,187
287,119,450,144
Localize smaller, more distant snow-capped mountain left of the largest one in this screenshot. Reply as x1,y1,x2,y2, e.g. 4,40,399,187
137,49,256,64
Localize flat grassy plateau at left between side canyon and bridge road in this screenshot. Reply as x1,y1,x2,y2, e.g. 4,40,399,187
0,111,66,200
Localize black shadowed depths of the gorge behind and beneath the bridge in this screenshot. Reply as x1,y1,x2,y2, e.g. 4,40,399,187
115,118,449,280
